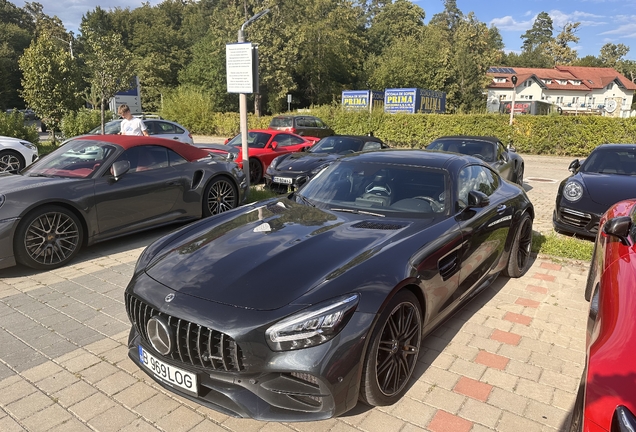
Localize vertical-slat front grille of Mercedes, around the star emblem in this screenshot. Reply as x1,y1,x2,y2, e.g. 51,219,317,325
125,293,244,372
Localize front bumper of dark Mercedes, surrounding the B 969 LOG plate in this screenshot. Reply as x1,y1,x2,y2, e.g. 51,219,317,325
126,279,375,421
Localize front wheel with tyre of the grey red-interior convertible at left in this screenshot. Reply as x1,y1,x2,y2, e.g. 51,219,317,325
15,206,83,270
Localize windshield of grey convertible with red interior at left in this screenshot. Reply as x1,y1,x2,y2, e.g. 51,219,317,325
22,139,117,178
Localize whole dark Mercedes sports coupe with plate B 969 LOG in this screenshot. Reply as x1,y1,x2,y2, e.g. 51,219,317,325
125,150,534,421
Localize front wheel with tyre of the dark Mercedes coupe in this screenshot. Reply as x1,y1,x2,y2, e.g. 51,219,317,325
360,291,422,406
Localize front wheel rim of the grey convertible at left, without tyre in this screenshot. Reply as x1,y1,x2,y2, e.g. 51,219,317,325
24,212,79,265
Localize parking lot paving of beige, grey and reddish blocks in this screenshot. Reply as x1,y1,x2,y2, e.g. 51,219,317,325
0,151,587,432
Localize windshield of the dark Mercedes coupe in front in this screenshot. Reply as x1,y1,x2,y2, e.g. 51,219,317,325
299,158,450,216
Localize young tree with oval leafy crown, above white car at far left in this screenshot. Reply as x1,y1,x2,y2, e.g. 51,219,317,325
19,32,82,144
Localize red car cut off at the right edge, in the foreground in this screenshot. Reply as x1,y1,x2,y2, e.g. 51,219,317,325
569,199,636,432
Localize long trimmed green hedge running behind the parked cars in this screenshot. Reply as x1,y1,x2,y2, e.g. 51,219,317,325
165,100,636,156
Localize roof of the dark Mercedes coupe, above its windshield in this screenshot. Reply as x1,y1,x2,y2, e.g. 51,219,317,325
343,149,480,169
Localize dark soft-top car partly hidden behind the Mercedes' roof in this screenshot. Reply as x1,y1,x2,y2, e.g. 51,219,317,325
426,135,525,186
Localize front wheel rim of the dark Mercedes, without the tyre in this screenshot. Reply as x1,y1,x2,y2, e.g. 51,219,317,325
376,303,422,397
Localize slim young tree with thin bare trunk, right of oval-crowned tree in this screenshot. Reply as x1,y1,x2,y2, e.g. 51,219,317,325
82,33,134,134
